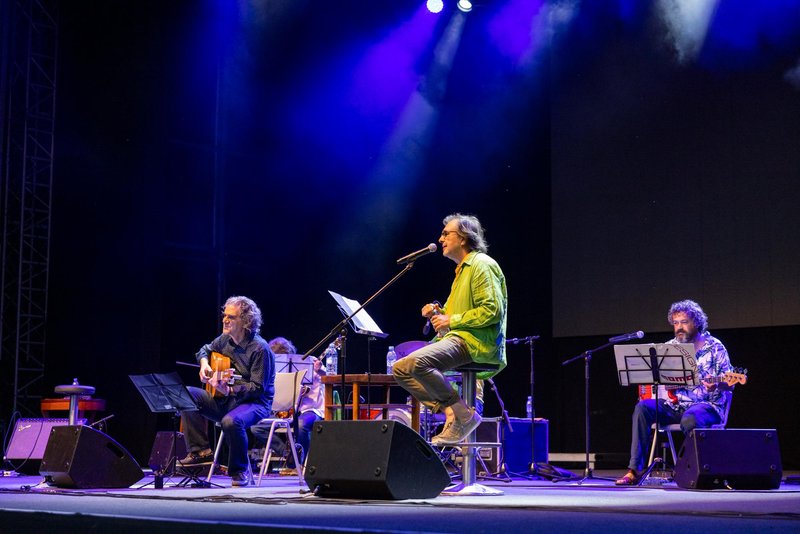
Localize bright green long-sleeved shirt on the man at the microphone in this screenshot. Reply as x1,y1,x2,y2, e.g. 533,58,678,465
443,251,508,379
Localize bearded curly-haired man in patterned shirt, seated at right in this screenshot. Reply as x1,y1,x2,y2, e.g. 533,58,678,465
616,300,733,486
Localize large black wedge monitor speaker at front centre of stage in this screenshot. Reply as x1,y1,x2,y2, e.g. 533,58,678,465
305,421,450,499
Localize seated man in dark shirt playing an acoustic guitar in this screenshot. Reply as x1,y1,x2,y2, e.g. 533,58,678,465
180,297,275,486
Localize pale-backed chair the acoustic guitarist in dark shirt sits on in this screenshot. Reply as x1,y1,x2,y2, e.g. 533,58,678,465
206,369,306,486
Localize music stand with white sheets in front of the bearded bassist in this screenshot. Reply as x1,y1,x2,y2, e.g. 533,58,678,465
614,343,699,484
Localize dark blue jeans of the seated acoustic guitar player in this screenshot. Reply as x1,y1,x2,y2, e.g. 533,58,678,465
181,386,270,475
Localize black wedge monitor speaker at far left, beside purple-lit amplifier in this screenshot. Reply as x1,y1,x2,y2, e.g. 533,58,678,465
39,425,144,488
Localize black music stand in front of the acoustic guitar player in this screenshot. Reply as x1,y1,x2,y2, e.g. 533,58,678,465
128,372,211,489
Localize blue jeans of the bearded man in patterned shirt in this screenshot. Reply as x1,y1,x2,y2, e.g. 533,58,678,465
628,399,721,473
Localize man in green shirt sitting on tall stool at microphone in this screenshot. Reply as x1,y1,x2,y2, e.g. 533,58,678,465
392,213,508,446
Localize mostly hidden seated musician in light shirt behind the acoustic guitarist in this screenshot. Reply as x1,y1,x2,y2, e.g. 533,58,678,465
250,337,325,472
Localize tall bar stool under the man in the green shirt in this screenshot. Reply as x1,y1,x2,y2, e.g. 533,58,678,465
442,362,504,495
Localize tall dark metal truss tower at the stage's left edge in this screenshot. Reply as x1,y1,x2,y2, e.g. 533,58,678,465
0,0,58,416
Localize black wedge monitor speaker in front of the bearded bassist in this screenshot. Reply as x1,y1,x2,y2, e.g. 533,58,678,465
675,428,783,489
